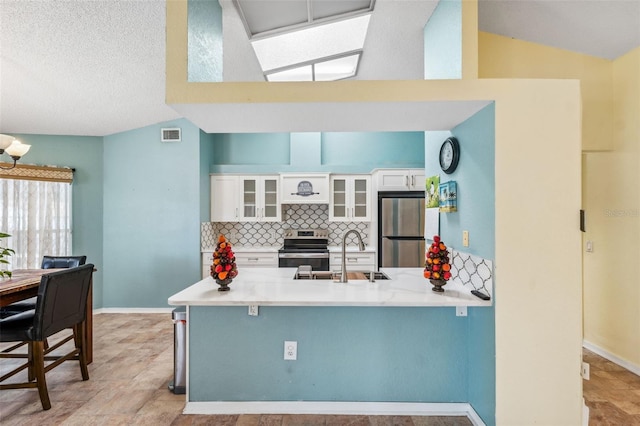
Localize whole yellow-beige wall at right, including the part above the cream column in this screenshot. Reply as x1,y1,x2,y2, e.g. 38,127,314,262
479,33,640,372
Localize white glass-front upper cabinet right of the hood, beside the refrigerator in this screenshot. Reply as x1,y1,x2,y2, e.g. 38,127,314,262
329,175,371,222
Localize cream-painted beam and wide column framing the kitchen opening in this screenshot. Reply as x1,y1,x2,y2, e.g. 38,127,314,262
167,1,582,425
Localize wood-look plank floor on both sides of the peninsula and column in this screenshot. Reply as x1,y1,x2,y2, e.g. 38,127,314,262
0,314,640,426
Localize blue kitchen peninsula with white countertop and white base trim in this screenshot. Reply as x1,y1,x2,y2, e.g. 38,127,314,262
169,268,493,415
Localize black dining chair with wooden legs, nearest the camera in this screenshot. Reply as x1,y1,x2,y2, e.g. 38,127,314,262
0,264,93,410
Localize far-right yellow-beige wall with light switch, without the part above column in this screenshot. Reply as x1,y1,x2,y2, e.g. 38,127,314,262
583,48,640,366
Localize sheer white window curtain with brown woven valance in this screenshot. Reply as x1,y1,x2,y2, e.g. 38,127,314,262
0,166,73,270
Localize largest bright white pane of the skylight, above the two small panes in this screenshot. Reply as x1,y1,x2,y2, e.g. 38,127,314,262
251,13,371,72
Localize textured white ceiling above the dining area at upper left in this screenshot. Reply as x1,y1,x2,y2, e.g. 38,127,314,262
0,0,180,136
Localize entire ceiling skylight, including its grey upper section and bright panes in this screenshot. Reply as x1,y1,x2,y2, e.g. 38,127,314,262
233,0,375,81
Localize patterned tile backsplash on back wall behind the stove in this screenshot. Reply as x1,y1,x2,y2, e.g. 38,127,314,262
200,204,371,250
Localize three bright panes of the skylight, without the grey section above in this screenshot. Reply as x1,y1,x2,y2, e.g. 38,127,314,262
251,13,371,81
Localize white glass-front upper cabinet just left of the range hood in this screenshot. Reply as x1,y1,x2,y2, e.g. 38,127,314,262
238,175,282,222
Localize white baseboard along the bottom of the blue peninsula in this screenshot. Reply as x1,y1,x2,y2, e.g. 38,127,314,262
183,401,485,426
